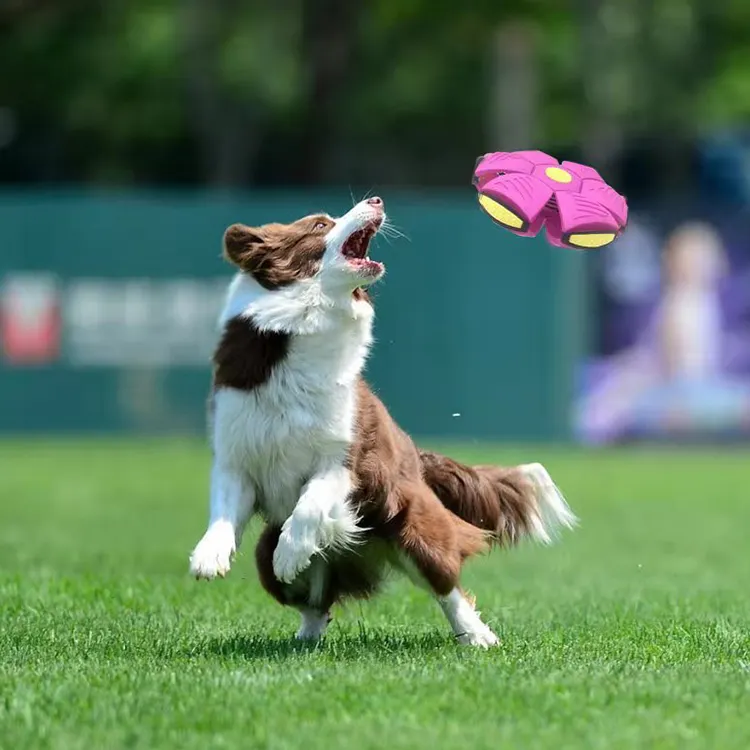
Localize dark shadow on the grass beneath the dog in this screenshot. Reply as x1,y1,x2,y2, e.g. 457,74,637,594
189,632,454,661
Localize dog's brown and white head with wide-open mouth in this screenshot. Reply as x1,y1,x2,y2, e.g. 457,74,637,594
224,198,385,294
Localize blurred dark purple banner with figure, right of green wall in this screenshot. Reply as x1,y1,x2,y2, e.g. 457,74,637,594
574,208,750,444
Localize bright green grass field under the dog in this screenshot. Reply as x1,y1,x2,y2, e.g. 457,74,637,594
0,441,750,750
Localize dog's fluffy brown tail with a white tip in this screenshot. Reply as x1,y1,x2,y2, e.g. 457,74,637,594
420,451,577,546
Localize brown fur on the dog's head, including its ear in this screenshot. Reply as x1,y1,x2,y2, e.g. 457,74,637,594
224,214,334,290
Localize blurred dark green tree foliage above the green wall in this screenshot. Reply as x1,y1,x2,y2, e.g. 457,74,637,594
0,0,750,185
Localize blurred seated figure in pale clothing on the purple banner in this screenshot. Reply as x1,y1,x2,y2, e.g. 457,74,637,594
578,221,750,442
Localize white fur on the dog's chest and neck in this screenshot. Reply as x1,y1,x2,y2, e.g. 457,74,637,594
213,274,372,523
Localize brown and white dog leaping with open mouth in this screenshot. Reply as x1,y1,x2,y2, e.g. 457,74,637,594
190,198,575,647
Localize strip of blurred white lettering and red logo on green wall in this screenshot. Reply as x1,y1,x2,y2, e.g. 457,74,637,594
0,272,227,367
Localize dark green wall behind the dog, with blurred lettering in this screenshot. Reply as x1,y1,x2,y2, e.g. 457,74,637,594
0,187,583,440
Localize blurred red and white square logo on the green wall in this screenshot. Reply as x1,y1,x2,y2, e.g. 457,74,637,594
0,274,61,365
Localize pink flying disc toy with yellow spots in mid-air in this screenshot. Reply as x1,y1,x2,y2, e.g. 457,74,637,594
472,151,628,250
